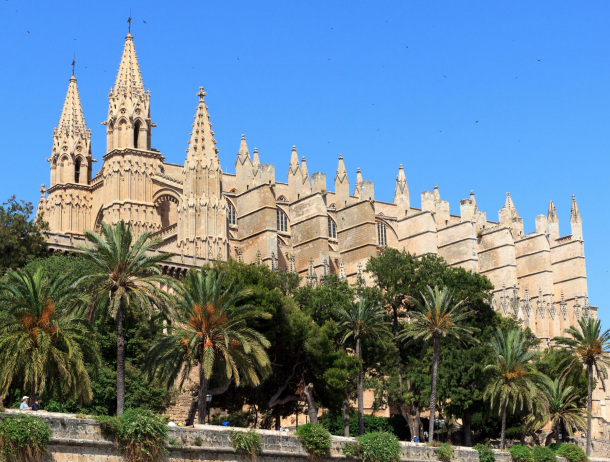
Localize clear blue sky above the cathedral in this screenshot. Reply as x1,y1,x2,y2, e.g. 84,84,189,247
0,0,610,327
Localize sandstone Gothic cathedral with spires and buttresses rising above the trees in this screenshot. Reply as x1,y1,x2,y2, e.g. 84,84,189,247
38,30,605,434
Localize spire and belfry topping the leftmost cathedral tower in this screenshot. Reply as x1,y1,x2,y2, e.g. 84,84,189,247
48,75,93,187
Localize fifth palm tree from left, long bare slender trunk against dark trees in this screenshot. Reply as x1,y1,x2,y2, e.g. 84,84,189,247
399,286,478,442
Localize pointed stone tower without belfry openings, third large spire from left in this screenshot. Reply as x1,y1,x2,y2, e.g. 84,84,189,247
178,87,229,260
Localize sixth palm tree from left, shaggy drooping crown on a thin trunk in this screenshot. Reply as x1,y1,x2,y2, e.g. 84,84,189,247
483,328,548,449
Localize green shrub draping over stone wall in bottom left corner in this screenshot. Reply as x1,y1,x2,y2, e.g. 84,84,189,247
0,415,51,462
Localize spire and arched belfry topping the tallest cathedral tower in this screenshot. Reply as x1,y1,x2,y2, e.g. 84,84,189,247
102,34,155,152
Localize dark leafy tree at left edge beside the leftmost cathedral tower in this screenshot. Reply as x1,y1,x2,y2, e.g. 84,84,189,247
0,196,48,274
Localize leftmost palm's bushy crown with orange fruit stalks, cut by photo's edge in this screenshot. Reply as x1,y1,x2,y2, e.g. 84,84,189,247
0,268,99,402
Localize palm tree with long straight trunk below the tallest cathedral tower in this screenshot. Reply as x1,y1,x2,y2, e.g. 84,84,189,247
78,220,176,415
